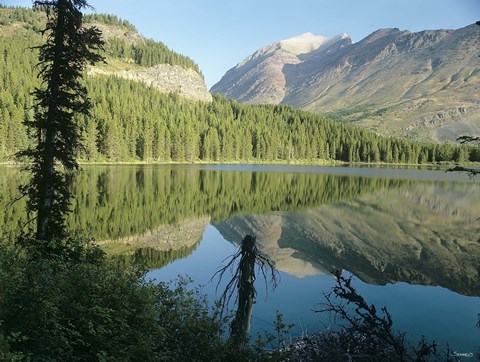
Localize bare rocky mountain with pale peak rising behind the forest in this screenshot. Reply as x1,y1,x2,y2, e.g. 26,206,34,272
211,24,480,141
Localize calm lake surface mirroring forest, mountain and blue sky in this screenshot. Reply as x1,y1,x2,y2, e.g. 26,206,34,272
0,165,480,352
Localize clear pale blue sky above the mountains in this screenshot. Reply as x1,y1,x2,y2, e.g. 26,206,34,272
0,0,480,88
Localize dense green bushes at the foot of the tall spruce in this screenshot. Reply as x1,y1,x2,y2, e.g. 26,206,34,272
0,238,278,361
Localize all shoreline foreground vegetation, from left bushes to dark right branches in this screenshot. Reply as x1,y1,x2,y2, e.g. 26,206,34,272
0,237,473,361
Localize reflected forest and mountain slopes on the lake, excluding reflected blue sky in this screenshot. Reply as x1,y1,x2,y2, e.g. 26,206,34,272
0,166,480,296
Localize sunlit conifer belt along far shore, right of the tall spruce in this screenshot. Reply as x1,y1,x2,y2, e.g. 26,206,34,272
76,77,480,163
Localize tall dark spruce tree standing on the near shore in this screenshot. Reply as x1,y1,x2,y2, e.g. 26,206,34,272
22,0,103,240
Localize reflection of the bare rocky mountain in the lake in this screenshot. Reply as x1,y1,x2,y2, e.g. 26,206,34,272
215,184,480,296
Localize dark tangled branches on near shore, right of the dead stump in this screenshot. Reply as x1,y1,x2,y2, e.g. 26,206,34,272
312,271,456,361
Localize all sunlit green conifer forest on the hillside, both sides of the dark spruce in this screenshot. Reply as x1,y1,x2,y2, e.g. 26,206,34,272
0,8,480,163
